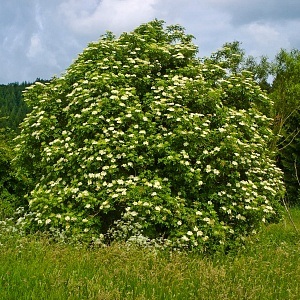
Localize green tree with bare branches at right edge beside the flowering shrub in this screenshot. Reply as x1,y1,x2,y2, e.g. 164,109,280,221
270,50,300,204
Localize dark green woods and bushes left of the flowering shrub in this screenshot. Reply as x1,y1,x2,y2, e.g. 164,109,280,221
0,82,31,218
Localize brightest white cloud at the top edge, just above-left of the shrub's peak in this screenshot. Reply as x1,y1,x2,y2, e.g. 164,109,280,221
59,0,158,36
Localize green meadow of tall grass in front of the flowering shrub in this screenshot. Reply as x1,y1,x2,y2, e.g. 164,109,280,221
0,209,300,300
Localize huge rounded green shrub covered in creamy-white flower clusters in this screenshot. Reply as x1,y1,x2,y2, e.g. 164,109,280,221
16,21,283,249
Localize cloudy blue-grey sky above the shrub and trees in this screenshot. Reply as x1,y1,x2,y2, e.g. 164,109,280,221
0,0,300,84
